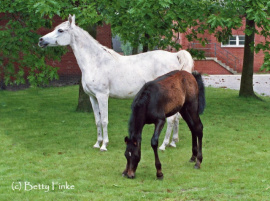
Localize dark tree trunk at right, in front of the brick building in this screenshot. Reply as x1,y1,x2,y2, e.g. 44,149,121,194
239,19,257,97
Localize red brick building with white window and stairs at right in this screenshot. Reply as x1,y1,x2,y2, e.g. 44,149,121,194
177,20,265,74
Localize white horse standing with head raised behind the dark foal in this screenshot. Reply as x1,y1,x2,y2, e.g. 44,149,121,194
39,15,193,151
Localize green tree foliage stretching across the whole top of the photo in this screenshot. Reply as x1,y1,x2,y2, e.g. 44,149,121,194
0,0,270,93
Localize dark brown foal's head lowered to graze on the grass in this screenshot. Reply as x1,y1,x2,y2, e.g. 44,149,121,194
123,137,141,178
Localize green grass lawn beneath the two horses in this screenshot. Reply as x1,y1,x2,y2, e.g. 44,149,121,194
0,86,270,201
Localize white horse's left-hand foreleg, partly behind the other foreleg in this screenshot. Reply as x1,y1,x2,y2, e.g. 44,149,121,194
90,96,103,149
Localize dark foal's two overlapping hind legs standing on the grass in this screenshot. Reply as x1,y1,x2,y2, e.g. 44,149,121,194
181,104,203,169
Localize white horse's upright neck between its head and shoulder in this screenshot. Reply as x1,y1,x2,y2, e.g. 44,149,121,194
70,27,116,73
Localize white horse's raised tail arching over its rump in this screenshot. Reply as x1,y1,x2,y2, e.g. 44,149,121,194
177,50,194,73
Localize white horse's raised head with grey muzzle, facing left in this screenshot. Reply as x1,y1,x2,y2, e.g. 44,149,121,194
38,15,75,48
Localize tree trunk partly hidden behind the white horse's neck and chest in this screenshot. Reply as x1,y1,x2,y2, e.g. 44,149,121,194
76,25,97,112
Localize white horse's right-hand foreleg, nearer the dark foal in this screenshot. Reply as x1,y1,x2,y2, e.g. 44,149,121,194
96,94,109,151
